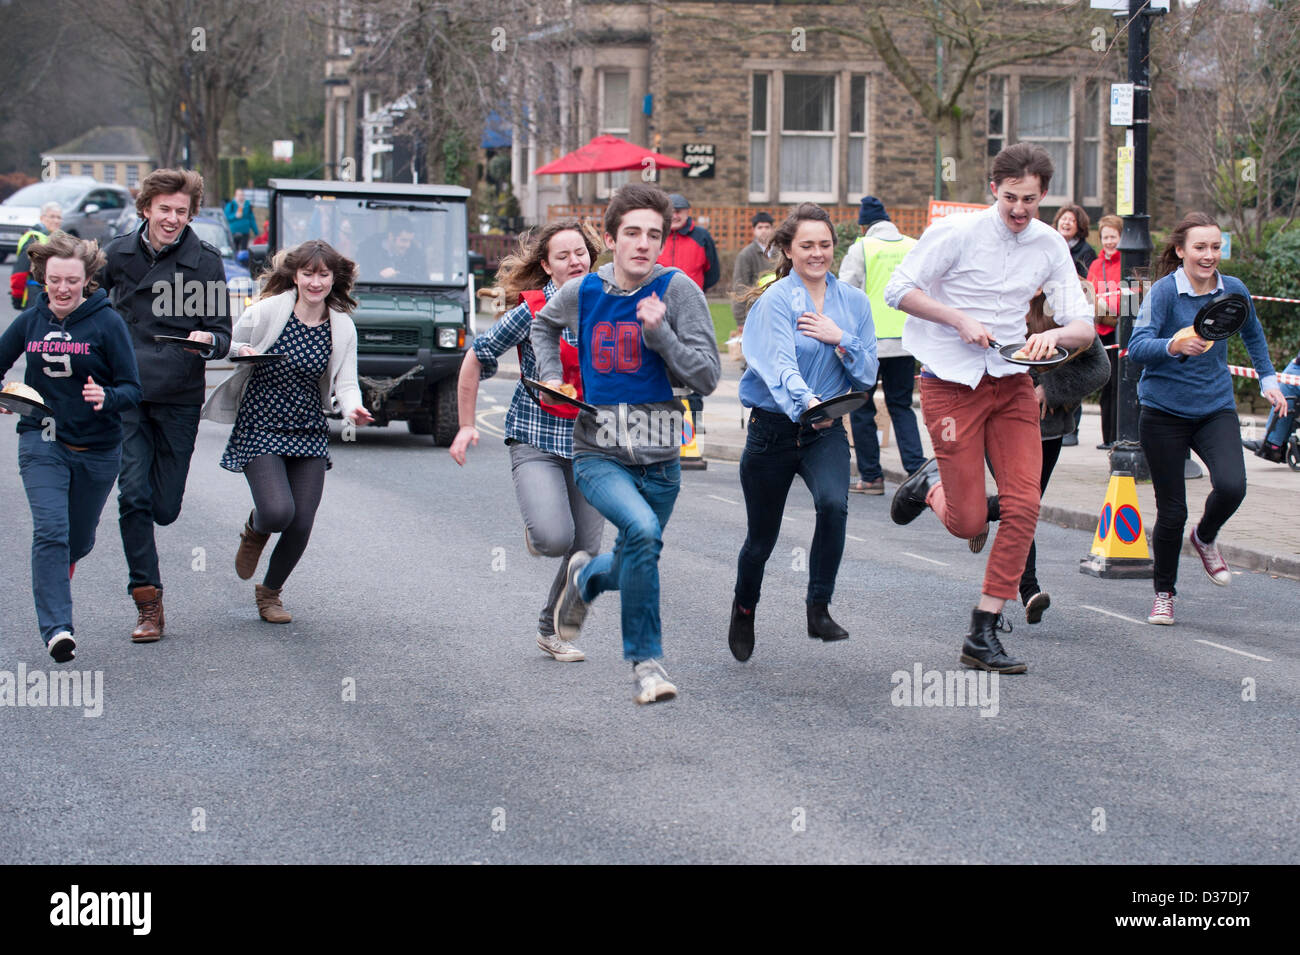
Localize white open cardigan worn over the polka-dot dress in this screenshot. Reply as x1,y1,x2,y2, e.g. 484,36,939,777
203,288,361,425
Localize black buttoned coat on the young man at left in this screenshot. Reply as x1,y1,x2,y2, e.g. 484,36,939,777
95,223,230,404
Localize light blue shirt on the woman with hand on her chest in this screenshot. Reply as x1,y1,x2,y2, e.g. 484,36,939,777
740,272,879,421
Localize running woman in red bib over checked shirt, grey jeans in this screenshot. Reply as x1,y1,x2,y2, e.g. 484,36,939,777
450,220,605,663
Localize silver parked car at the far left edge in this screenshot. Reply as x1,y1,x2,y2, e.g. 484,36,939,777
0,175,135,257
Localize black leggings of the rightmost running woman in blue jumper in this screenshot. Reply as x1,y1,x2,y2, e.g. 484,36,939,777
1138,407,1245,594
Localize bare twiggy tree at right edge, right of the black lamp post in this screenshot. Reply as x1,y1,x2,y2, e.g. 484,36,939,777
1152,0,1300,256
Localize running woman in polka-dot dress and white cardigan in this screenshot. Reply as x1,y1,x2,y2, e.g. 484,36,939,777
203,239,374,624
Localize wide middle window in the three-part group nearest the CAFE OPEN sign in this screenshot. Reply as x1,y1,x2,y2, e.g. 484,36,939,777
780,73,837,203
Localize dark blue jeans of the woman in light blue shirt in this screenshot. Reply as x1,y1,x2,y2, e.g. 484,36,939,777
736,407,847,609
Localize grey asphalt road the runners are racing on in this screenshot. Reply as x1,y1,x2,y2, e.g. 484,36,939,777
0,335,1300,863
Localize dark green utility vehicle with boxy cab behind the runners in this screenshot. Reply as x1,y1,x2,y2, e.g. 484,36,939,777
262,179,476,447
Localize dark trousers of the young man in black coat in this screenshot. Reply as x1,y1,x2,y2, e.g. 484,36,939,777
117,401,202,592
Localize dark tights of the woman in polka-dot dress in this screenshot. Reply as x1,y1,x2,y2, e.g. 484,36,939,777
244,455,325,590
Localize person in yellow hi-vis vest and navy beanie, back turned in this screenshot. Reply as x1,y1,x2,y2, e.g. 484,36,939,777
839,196,926,494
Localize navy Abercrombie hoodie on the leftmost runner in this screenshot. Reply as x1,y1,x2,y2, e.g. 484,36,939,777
0,288,140,451
